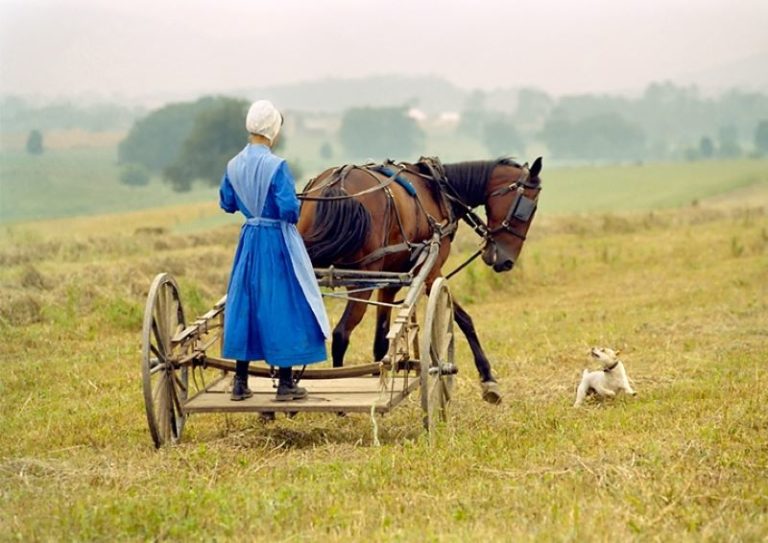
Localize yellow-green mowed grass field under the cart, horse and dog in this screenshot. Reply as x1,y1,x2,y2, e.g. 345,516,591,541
0,186,768,541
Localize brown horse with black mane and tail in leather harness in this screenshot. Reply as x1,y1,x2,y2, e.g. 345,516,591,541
298,158,542,403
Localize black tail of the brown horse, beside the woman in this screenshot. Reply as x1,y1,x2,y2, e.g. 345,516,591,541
304,185,371,268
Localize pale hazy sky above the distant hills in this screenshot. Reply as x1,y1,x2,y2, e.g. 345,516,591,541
0,0,768,101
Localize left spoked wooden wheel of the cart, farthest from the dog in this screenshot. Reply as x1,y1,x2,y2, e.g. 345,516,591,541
141,273,189,448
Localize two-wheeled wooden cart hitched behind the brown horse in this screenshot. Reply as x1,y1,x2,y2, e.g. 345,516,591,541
141,235,456,447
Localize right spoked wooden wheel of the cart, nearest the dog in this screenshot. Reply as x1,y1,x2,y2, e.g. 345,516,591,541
419,277,456,433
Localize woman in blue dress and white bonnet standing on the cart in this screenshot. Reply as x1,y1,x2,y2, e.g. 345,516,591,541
219,100,330,401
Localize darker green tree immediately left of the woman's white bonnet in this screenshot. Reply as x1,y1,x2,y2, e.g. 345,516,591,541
163,98,248,191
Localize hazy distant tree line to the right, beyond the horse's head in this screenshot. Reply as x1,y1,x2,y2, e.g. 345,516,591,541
465,83,768,161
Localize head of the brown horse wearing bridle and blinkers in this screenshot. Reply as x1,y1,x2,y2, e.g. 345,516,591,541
483,157,542,272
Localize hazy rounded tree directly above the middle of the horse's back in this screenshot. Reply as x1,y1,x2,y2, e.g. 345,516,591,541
339,107,424,158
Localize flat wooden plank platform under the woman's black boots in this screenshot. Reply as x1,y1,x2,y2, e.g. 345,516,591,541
184,374,419,413
